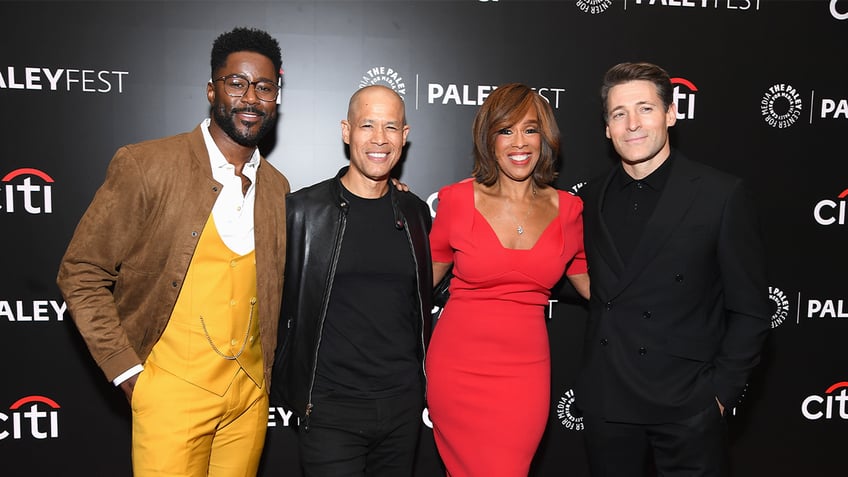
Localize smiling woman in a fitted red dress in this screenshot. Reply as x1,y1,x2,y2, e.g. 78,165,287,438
426,83,589,477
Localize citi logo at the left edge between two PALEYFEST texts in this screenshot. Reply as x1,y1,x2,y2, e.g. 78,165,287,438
0,168,53,215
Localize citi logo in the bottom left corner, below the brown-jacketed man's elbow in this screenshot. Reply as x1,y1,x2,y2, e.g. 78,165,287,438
0,396,59,440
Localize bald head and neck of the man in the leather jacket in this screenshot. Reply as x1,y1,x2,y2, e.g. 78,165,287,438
342,86,409,197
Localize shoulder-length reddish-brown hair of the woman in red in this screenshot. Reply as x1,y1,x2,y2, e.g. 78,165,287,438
471,83,559,187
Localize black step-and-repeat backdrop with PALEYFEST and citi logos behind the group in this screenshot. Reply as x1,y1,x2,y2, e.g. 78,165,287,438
0,0,848,477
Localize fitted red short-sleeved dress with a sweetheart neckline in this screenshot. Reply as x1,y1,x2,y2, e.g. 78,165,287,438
426,180,586,477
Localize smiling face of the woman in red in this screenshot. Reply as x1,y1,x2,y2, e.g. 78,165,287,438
494,107,542,181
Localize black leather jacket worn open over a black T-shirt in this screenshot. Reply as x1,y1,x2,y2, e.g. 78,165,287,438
271,167,433,426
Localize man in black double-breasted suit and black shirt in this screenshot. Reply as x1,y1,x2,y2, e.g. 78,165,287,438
575,63,771,477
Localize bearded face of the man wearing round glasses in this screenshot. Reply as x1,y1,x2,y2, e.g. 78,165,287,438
206,51,277,148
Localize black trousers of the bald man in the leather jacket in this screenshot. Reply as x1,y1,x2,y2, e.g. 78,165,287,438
298,389,424,477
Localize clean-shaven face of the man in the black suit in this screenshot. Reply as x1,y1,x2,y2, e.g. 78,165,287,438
606,80,677,170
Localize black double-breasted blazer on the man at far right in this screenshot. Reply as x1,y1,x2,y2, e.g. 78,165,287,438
575,153,771,423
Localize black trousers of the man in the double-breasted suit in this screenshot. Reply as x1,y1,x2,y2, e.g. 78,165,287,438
583,404,729,477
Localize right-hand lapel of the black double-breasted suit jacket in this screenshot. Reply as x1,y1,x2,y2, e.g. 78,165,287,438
612,155,700,296
